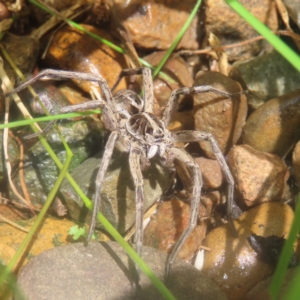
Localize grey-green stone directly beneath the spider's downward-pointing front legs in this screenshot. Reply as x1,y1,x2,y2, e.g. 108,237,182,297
60,150,169,233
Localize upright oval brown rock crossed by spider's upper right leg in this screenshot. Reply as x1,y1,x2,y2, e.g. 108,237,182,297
193,71,247,159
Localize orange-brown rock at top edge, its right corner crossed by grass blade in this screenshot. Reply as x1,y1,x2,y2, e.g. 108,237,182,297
114,0,199,50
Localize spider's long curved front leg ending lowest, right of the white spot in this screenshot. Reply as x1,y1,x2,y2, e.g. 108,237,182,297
165,147,202,282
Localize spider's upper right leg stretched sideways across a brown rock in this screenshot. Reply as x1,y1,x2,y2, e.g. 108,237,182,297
162,85,244,127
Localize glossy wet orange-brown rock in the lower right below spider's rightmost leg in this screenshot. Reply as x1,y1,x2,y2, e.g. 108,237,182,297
202,202,294,300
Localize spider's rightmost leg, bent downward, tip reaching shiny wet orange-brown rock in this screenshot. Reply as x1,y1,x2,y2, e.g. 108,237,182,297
171,130,237,237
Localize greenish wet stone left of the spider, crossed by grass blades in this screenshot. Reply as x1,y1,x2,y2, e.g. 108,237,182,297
10,118,104,205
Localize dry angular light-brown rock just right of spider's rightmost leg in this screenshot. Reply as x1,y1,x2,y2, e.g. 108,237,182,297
228,145,289,206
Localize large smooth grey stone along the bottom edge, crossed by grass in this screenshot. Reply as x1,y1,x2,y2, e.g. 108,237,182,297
16,242,227,300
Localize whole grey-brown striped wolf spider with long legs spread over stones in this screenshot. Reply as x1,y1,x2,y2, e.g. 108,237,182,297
7,67,235,279
